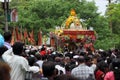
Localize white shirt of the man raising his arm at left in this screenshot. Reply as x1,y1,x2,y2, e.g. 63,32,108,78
2,48,29,80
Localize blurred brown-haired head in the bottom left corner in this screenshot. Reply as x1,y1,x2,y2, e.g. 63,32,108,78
0,62,11,80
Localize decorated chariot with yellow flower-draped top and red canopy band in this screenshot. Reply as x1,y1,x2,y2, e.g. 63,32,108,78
50,9,96,50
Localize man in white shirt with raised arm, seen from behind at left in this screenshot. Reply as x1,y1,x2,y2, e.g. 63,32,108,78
2,42,37,80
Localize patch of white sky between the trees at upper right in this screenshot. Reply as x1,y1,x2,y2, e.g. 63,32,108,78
87,0,108,15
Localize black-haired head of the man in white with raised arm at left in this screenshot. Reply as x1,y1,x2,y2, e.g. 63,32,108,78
12,42,24,55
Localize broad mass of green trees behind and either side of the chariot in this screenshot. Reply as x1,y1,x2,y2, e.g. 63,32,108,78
5,0,120,49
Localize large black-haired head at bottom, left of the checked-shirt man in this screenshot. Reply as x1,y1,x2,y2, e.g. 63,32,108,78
42,61,57,78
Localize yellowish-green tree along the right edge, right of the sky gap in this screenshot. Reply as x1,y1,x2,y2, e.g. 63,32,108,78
106,3,120,48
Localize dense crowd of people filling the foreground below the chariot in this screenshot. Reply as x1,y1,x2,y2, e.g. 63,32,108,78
0,32,120,80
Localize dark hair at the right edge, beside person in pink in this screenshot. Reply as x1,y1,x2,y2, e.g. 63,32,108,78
112,58,120,80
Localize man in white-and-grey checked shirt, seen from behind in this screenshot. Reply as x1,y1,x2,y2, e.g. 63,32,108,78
71,56,94,80
